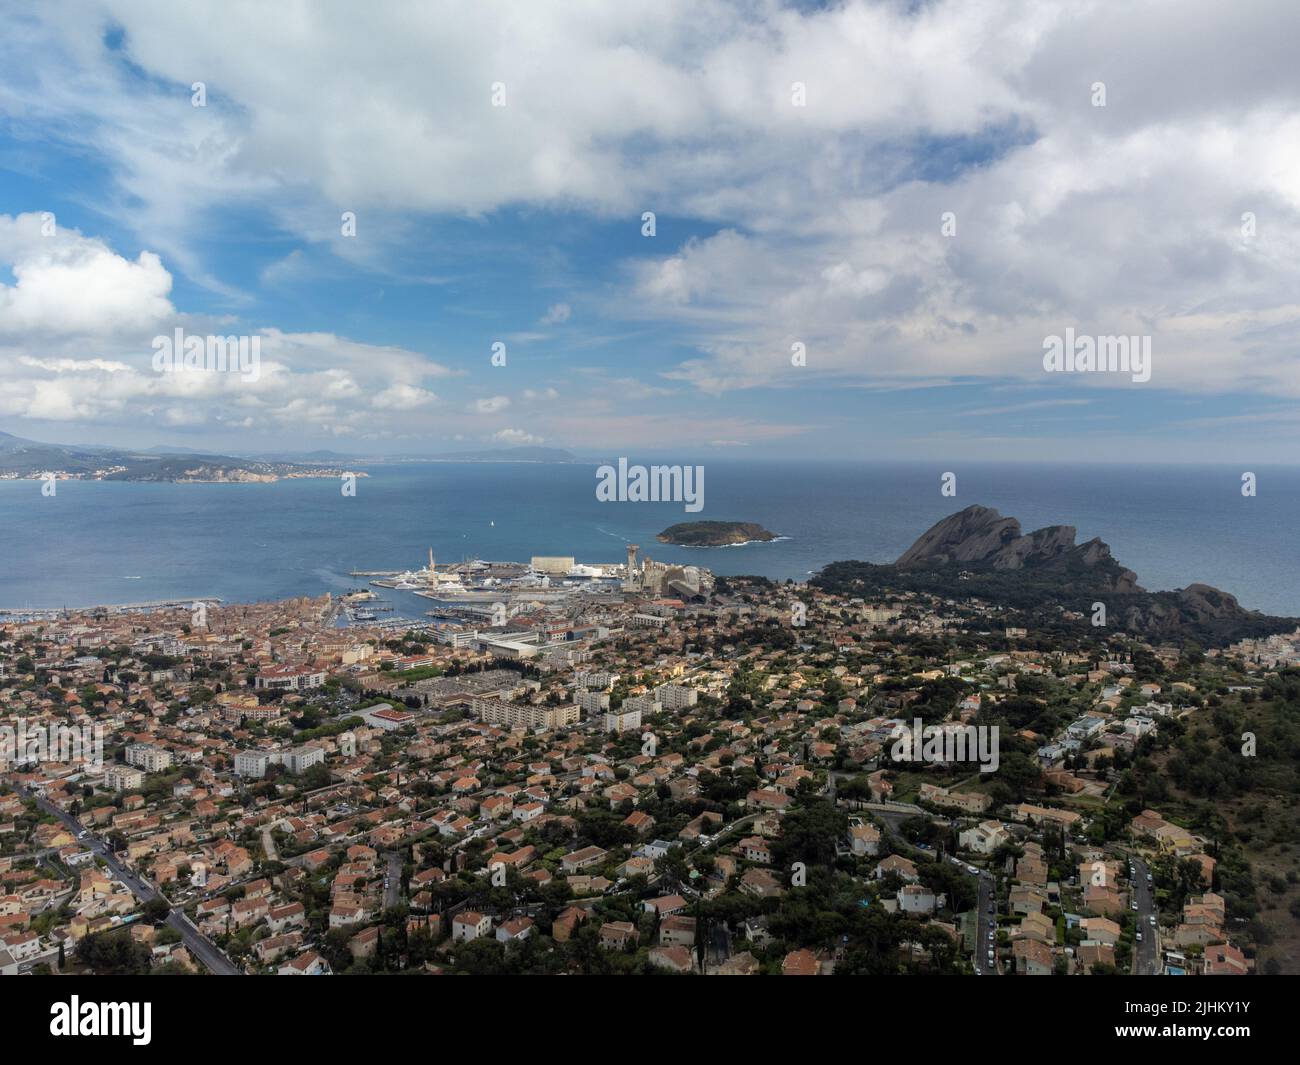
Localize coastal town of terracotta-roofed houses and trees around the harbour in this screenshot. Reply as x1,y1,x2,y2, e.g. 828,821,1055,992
0,551,1300,977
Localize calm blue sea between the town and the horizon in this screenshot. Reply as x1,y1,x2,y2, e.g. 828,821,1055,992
0,459,1300,618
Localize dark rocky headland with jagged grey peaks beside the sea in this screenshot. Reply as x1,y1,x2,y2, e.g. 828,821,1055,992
810,506,1300,644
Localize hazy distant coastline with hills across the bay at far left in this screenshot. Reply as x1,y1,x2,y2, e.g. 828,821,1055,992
0,432,364,482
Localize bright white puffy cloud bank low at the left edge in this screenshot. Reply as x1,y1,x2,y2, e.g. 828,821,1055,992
0,215,454,434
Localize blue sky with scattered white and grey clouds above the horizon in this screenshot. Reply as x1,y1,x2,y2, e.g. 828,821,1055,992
0,0,1300,464
